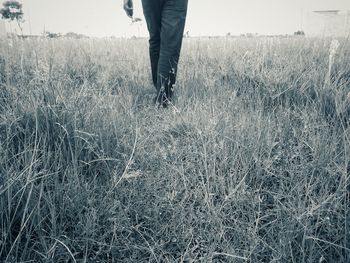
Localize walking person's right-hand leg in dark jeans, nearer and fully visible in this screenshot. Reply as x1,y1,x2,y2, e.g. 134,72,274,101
157,0,188,102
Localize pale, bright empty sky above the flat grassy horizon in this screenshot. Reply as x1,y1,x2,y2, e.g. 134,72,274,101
0,0,350,37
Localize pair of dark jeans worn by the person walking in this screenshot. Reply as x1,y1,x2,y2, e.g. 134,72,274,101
142,0,188,103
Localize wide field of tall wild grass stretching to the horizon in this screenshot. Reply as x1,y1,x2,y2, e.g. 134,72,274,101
0,37,350,263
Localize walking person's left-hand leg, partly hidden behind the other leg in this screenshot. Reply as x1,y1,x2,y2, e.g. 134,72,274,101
142,0,161,88
